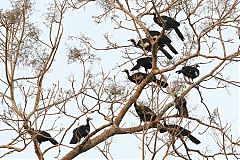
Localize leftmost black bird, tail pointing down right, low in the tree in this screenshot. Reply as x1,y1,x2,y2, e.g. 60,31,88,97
29,129,59,145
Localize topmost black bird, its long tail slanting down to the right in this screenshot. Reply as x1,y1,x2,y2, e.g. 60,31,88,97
153,13,185,41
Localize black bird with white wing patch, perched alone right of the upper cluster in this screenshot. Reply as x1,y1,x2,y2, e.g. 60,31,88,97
176,64,200,81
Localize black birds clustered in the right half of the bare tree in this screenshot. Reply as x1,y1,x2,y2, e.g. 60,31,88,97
126,13,201,144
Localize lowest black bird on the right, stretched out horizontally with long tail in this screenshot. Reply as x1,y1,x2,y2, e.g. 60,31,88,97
159,122,201,144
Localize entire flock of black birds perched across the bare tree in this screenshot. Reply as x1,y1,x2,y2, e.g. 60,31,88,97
25,13,201,148
